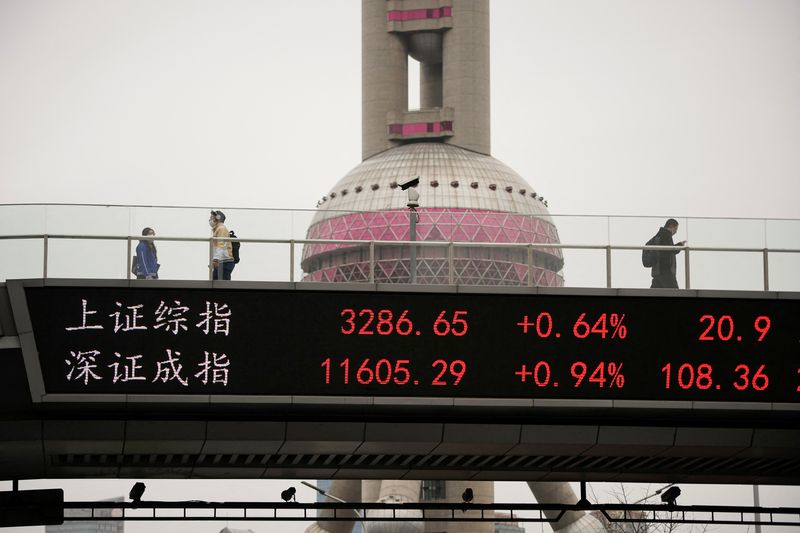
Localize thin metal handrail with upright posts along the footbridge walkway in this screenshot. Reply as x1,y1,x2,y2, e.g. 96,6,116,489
0,233,800,290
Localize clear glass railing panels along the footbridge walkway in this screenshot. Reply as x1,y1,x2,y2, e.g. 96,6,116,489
0,204,800,291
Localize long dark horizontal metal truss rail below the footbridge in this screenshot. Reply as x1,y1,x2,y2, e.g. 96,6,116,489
56,500,800,528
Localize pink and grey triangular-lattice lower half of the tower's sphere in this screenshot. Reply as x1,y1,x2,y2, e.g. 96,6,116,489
302,208,564,286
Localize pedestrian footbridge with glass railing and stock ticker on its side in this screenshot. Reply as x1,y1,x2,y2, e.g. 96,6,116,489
0,206,800,484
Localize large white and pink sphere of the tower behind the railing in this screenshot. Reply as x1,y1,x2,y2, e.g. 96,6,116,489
302,142,564,287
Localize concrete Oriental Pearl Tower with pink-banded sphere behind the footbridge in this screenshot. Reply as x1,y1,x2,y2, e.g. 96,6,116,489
302,0,605,533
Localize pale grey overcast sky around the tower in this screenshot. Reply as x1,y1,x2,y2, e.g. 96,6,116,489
0,0,800,532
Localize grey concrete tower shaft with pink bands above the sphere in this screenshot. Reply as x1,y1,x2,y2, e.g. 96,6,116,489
361,0,491,160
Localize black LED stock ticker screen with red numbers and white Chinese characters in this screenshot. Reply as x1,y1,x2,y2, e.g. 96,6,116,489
21,286,800,402
